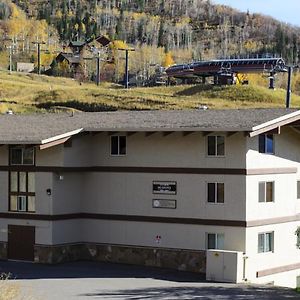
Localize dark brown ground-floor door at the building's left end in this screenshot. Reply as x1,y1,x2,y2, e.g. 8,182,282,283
8,225,35,261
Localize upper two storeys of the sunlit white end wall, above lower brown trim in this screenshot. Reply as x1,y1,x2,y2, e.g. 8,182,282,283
246,127,300,219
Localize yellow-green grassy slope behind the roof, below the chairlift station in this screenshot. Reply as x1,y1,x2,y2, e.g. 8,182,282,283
0,71,300,113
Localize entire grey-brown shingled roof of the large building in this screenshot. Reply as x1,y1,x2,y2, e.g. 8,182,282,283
0,109,300,144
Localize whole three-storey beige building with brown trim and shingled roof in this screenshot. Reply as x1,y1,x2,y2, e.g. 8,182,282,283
0,109,300,286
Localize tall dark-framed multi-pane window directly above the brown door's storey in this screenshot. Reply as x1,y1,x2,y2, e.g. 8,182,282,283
9,172,35,212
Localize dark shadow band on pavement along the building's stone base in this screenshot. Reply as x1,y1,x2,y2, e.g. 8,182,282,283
0,261,205,282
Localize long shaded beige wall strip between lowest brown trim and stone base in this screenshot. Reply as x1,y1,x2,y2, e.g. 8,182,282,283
83,220,245,251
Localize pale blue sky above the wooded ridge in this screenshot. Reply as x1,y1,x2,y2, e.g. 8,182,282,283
212,0,300,26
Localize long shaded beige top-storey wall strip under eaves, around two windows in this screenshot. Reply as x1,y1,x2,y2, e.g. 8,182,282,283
88,132,246,168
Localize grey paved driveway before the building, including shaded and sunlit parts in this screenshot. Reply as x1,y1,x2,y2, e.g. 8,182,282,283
0,261,300,300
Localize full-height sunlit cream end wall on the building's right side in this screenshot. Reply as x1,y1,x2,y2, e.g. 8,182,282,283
246,127,300,287
